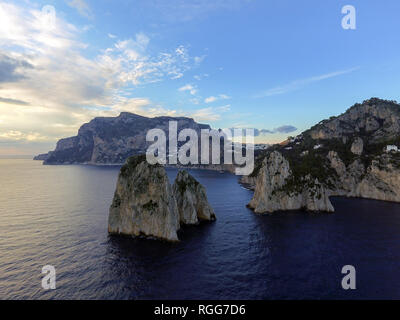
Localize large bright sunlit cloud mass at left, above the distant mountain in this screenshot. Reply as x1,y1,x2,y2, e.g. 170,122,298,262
0,1,206,153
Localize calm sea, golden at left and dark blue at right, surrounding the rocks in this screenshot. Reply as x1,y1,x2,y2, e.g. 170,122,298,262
0,159,400,299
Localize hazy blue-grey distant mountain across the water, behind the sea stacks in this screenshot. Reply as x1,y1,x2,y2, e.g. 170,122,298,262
40,112,210,164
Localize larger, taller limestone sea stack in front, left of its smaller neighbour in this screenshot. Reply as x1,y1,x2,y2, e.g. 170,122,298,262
108,156,179,241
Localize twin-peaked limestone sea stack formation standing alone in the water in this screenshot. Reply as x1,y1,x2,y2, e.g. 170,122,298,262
108,156,215,241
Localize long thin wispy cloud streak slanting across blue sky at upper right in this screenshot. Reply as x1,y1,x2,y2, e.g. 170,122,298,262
255,67,359,98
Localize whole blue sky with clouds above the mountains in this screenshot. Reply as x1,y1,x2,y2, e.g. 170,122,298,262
0,0,400,155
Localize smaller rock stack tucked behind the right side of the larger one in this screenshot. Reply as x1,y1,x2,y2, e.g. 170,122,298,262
172,170,215,224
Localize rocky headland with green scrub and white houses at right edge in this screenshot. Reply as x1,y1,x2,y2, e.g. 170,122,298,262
249,99,400,213
